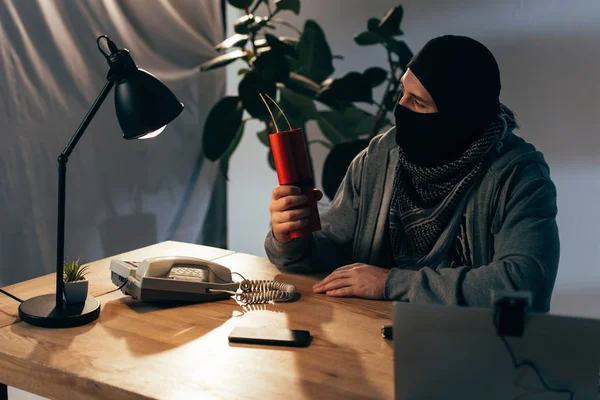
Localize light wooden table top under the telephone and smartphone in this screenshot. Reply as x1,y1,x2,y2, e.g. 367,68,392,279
0,242,394,400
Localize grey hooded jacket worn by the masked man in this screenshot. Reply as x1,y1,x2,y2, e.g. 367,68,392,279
265,129,560,312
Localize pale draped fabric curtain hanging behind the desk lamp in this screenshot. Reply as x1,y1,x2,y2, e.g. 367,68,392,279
0,0,226,286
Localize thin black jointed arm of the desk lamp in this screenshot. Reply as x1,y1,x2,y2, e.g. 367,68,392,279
56,79,115,308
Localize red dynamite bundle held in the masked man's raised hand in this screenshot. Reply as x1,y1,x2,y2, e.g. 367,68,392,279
269,129,321,239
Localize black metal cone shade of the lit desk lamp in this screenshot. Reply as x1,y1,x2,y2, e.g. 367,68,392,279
115,68,183,139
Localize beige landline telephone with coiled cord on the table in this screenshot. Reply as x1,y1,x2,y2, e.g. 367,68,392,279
110,257,296,305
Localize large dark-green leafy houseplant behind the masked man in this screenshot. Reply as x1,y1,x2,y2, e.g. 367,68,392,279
200,0,413,199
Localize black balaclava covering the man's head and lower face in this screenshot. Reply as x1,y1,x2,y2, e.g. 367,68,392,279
394,35,501,166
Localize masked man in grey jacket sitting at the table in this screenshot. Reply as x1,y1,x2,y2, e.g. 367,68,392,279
265,35,559,311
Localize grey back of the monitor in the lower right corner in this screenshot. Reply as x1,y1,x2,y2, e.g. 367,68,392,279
393,302,600,400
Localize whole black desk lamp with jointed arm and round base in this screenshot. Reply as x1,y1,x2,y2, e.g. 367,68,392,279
19,35,183,328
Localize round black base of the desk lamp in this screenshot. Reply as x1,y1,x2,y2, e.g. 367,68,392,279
19,294,100,328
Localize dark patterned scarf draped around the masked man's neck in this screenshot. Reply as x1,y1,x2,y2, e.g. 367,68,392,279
390,105,517,266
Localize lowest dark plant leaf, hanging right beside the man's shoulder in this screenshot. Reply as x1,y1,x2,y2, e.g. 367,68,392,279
322,140,369,200
